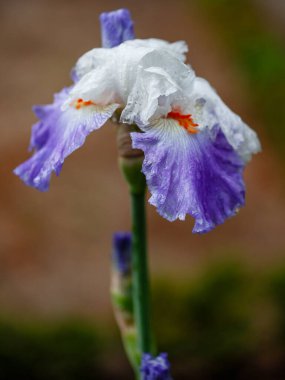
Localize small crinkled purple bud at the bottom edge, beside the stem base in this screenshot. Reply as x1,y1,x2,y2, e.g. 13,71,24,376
141,353,172,380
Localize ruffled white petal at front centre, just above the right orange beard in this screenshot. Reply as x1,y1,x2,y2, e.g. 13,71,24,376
118,50,195,125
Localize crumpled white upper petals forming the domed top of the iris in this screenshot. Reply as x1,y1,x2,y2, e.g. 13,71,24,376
68,39,195,123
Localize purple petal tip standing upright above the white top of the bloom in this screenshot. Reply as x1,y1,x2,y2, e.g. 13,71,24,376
100,9,135,48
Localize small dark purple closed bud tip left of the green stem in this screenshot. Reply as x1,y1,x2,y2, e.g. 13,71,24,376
113,232,132,275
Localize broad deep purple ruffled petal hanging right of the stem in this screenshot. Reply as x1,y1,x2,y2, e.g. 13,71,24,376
132,119,245,233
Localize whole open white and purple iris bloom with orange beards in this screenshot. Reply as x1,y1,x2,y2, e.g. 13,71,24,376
15,10,260,233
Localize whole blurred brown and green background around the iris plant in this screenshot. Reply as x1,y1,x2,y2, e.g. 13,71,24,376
0,0,285,380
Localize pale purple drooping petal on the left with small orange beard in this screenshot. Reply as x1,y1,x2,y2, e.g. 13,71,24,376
14,89,118,191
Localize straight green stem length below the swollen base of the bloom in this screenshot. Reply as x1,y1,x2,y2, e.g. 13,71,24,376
131,190,152,362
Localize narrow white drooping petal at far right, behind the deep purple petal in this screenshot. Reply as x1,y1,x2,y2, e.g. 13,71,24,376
192,77,261,163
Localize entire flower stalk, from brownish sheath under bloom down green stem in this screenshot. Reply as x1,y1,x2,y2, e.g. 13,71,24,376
118,126,153,373
